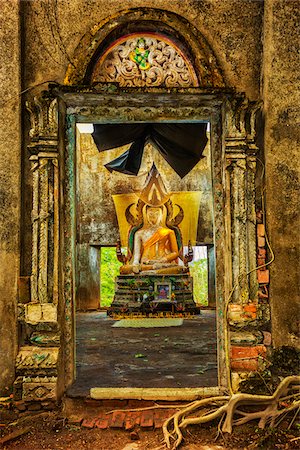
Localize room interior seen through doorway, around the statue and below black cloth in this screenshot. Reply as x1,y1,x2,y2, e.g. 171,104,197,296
69,120,218,396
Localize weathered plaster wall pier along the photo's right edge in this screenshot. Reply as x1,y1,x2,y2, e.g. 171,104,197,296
263,0,300,346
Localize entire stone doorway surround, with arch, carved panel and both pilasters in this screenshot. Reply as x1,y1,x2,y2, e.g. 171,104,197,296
15,9,268,401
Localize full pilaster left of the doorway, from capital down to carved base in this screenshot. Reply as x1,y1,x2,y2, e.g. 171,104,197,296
15,96,60,402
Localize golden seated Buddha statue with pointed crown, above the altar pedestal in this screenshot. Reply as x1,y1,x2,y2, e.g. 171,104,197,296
117,164,192,275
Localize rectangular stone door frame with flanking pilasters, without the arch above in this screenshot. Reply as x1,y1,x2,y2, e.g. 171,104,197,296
16,87,257,404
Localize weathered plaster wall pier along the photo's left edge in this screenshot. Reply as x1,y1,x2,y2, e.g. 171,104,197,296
0,0,21,396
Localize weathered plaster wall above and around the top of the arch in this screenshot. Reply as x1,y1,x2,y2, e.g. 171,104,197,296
25,0,263,99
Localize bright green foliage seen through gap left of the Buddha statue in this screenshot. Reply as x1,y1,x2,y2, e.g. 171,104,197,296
100,247,122,307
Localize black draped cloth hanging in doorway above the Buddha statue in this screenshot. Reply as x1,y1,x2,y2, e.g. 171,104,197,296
92,123,207,178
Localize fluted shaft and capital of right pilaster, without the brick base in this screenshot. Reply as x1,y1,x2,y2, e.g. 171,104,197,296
225,98,260,304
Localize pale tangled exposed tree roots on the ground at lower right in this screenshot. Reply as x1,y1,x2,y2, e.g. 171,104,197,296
163,376,300,449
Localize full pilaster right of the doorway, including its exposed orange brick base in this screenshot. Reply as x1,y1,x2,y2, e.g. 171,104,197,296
225,98,269,389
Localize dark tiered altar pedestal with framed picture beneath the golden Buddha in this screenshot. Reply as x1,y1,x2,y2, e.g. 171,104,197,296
108,274,200,315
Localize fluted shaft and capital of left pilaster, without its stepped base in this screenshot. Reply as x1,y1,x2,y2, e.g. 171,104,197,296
27,98,59,304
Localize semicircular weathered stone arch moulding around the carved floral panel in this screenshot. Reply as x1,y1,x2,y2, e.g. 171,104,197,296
64,8,226,88
